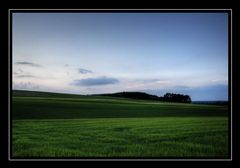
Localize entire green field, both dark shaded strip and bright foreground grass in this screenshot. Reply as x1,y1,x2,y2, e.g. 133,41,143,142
11,91,229,158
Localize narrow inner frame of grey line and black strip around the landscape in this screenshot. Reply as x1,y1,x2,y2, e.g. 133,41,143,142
9,9,232,161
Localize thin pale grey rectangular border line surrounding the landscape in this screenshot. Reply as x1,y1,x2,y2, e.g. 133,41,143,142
8,9,233,161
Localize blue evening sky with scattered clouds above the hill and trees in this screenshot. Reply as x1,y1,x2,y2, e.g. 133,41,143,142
12,13,228,101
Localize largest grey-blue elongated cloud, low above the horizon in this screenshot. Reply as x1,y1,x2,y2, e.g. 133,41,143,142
72,76,119,86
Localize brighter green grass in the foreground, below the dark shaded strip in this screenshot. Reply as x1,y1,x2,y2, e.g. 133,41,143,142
12,117,228,158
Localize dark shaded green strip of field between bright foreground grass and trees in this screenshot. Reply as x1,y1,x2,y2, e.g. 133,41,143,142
12,97,228,119
